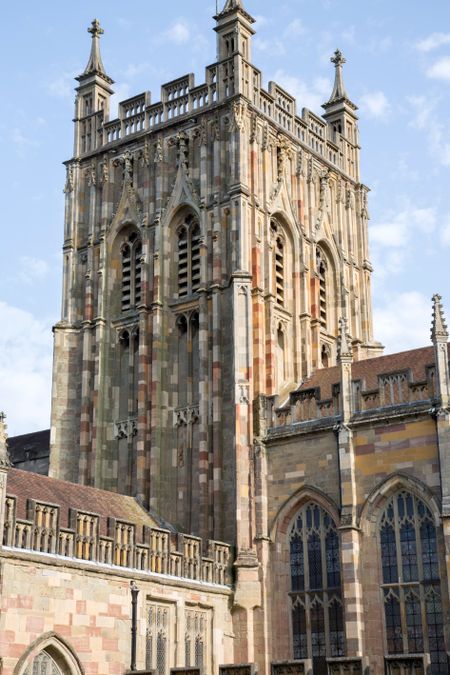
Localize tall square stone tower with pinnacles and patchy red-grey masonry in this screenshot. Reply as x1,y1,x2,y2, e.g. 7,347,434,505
50,0,381,548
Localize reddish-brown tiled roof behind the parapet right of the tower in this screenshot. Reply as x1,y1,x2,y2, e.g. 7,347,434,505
297,343,450,400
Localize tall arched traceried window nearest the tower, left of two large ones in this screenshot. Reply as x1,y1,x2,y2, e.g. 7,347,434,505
289,502,344,675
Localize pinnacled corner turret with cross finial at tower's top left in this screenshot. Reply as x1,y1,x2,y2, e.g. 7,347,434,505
74,19,114,157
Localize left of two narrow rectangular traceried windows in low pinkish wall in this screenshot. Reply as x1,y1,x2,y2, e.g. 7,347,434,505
145,602,171,675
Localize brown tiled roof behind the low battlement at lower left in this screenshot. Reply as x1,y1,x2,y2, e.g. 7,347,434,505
6,469,167,534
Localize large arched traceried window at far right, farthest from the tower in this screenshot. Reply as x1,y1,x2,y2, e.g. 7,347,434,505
380,492,448,675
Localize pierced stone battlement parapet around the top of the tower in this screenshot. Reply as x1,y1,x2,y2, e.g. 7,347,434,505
81,59,355,176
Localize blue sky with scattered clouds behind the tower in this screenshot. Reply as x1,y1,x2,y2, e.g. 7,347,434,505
0,0,450,435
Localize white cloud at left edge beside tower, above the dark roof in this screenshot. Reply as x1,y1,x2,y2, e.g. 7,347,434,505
0,301,52,435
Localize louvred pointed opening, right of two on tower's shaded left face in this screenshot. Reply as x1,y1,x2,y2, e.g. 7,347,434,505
178,215,200,298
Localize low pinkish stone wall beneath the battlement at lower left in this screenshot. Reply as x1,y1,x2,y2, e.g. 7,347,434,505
0,550,233,675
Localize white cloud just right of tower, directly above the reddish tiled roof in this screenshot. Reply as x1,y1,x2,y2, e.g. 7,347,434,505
374,291,431,353
